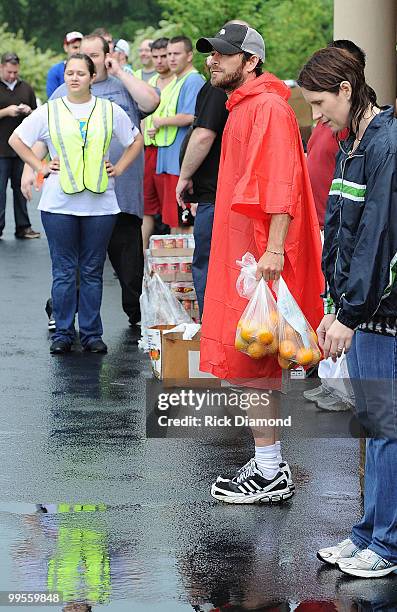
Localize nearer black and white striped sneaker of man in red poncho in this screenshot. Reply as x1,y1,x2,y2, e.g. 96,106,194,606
211,459,293,504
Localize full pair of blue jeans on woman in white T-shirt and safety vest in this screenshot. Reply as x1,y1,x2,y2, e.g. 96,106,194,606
41,211,117,346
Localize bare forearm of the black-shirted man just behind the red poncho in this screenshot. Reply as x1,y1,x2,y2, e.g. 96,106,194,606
176,127,216,208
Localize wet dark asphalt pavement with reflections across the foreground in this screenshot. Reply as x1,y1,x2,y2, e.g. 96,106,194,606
0,196,397,612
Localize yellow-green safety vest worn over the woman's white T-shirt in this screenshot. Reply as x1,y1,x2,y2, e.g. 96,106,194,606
48,98,113,195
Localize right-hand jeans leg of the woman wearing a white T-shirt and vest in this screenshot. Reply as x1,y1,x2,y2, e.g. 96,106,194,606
77,215,117,347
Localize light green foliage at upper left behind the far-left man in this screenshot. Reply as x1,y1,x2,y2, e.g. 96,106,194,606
0,24,62,101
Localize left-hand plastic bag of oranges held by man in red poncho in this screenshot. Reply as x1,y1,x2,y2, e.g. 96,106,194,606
235,279,278,359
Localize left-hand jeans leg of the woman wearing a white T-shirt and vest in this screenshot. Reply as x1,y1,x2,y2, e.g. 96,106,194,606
41,211,79,344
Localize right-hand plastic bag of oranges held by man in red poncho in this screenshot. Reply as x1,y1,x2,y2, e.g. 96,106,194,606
277,277,321,370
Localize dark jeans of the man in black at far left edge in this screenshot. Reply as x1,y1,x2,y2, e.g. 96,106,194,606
0,157,30,236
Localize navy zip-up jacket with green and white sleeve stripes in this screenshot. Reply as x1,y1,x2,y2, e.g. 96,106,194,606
322,106,397,329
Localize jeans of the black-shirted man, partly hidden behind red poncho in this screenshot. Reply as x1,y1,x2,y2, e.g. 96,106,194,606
192,202,215,318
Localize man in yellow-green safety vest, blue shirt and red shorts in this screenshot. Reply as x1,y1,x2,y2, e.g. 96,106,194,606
151,36,205,228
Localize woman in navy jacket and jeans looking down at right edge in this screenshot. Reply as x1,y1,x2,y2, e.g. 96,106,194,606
298,49,397,578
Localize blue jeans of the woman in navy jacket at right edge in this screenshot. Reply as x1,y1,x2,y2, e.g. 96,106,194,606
347,331,397,564
